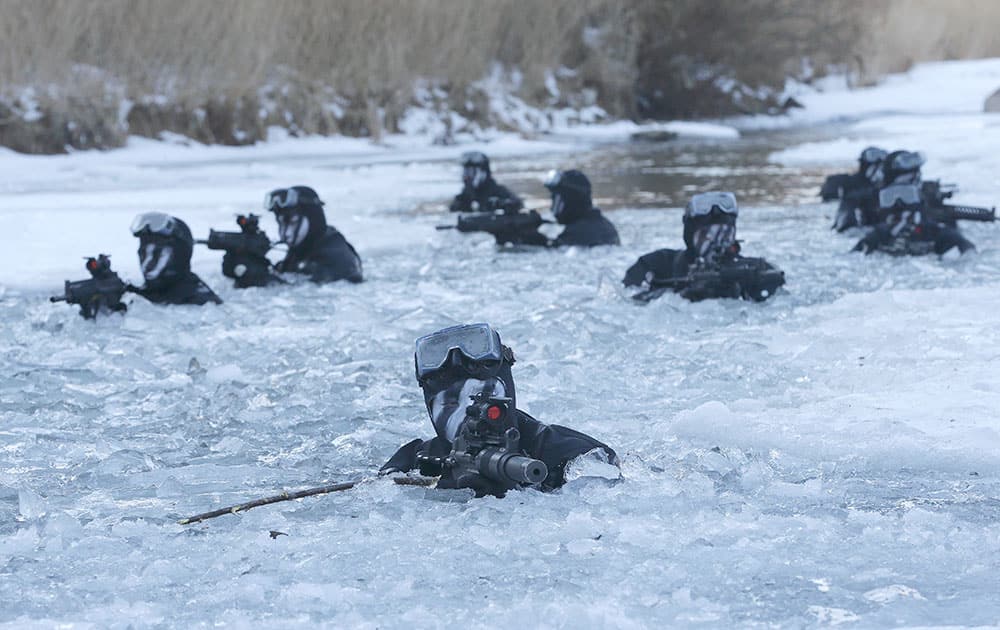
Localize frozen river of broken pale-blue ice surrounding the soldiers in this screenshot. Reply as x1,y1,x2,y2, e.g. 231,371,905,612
0,91,1000,628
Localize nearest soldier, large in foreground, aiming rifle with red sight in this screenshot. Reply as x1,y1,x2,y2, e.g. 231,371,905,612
380,324,619,496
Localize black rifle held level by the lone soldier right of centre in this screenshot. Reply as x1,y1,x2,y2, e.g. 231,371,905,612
632,256,785,303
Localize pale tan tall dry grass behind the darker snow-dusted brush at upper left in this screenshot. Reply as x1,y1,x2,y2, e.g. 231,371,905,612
0,0,617,97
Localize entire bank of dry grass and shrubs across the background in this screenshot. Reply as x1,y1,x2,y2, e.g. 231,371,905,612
0,0,1000,151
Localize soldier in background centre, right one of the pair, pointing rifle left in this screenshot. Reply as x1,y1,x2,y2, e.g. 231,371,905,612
455,170,619,247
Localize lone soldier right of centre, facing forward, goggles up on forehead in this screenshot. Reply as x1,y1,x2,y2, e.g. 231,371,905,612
622,191,785,302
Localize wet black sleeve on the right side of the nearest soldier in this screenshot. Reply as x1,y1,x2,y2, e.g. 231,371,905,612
518,411,619,488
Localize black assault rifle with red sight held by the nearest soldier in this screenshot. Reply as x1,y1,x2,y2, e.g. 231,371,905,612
417,392,549,490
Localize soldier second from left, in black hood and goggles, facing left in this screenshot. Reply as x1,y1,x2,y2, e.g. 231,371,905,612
264,186,362,283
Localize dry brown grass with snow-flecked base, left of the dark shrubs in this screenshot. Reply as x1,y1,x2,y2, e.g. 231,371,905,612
0,0,628,150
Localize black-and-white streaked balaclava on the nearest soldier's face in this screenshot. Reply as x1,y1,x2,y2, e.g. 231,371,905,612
418,346,517,442
